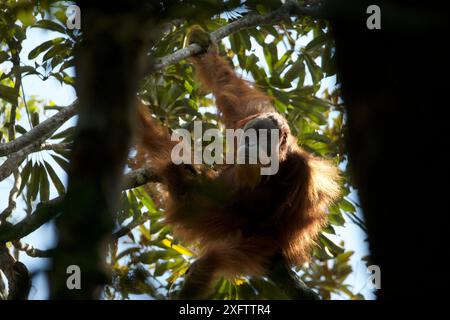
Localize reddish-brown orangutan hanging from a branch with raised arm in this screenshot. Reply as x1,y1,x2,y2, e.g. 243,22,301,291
135,28,339,299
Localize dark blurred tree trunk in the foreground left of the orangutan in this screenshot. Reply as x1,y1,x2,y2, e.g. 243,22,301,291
48,0,152,290
